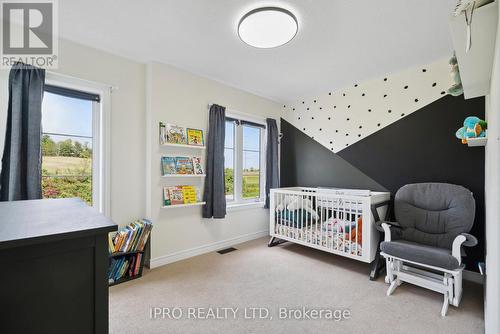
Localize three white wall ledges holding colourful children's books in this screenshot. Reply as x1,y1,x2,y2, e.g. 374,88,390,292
159,122,206,208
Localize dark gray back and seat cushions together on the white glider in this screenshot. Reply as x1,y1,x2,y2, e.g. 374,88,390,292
380,183,475,270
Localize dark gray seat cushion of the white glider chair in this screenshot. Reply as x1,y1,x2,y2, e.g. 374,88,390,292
380,240,460,270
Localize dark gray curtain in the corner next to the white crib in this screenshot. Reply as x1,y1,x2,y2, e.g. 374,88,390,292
264,118,280,208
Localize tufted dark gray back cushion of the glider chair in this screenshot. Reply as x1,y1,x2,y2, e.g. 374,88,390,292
394,183,476,251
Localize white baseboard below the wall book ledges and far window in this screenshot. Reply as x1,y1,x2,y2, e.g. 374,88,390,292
149,230,269,269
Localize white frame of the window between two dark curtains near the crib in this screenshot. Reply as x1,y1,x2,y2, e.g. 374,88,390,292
226,109,267,208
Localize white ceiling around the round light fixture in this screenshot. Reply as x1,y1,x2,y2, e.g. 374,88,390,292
59,0,456,102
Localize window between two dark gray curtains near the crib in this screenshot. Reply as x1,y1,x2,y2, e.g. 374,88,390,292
224,113,266,205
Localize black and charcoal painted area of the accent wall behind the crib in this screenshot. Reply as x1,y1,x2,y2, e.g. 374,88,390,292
281,96,485,271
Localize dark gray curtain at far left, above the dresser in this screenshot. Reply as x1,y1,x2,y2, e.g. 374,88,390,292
0,63,45,201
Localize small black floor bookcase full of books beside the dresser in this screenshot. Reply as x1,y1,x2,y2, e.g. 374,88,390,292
108,219,153,286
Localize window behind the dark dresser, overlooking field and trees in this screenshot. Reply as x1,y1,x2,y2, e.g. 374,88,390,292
41,78,105,212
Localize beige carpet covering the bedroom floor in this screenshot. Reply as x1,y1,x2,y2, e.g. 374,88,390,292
109,238,484,334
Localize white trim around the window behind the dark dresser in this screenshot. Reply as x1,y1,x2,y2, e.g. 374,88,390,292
45,72,112,217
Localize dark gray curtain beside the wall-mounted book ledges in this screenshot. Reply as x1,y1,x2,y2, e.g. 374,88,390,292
203,104,226,218
